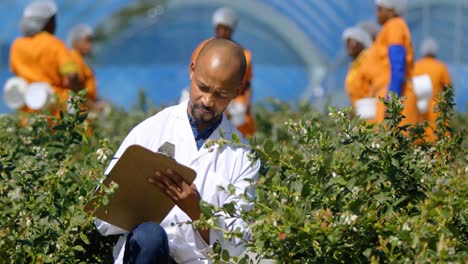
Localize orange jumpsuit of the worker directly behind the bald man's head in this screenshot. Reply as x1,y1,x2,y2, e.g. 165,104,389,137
192,38,255,137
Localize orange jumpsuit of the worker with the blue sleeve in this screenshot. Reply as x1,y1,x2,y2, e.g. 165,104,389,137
366,17,419,125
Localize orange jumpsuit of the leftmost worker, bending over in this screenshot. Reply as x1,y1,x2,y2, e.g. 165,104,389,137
10,32,78,112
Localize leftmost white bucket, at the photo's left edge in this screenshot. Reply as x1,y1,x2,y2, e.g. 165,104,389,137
3,76,28,110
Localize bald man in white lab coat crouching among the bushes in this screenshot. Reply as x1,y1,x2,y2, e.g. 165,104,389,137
96,39,260,263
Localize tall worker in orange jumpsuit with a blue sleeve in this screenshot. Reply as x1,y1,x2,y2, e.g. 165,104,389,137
366,0,420,125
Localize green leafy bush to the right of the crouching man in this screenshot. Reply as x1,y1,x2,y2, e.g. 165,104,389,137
207,89,468,263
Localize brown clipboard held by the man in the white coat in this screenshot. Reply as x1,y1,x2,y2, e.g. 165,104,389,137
85,145,196,231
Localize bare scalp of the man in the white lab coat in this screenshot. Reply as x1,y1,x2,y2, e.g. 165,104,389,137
195,38,246,83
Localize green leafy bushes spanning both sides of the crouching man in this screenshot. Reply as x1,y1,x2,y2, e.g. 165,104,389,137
0,90,468,263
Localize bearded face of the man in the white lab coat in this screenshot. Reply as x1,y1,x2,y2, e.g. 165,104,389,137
188,60,240,129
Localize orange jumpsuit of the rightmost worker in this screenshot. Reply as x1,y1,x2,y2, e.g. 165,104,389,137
413,57,451,141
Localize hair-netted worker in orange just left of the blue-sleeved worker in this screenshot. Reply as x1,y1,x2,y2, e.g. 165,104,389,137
343,27,372,117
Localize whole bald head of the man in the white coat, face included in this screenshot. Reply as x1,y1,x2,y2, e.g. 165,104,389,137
187,39,246,131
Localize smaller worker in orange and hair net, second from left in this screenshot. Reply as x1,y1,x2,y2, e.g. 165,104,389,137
68,24,97,104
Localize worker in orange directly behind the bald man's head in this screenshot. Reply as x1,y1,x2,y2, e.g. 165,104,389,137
192,7,255,137
